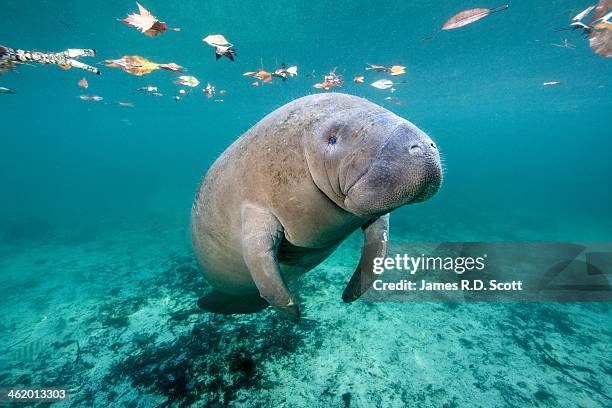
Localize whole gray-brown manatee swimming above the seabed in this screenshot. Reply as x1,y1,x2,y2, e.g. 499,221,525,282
191,93,442,317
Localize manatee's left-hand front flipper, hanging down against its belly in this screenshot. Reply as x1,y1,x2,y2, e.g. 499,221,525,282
241,206,300,318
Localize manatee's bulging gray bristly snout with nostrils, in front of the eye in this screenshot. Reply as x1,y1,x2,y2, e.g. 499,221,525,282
345,125,442,215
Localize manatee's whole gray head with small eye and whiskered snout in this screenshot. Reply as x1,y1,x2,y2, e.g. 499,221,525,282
305,107,442,217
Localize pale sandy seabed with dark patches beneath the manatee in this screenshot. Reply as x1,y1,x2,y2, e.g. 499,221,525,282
0,215,612,407
